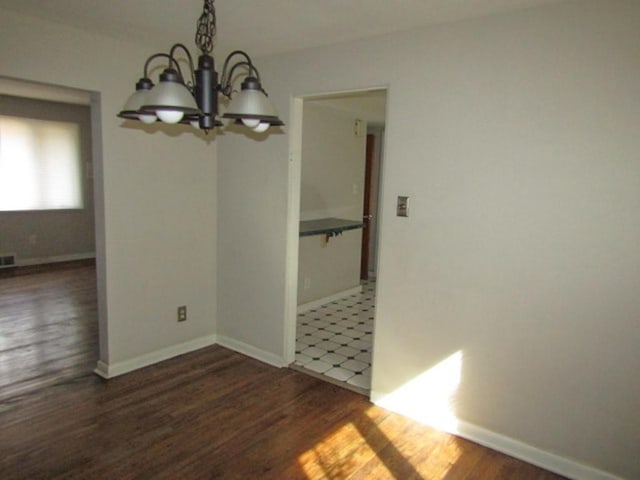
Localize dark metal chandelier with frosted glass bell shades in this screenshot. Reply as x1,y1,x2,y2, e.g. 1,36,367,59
118,0,284,132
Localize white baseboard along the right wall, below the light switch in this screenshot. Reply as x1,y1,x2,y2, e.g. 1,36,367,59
371,391,624,480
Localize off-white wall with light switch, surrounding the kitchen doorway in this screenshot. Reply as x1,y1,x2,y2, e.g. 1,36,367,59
218,0,640,479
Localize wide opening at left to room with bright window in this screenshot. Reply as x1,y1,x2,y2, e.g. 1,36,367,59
0,77,103,401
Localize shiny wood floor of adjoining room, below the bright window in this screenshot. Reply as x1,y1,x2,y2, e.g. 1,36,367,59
0,261,98,401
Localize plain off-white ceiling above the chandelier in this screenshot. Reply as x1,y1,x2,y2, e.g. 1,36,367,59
0,0,564,57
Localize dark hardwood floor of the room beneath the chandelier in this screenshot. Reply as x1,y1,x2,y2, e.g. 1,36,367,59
0,264,562,480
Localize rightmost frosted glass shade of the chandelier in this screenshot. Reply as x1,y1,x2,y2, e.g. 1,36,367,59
222,77,279,128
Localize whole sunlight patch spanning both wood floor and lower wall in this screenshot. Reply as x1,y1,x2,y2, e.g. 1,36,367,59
298,350,463,478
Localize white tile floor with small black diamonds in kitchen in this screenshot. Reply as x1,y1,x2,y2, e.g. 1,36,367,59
294,281,376,390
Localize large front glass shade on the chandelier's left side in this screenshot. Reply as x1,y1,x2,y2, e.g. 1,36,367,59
141,68,200,123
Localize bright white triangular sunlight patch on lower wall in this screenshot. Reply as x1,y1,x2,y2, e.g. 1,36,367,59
376,350,463,433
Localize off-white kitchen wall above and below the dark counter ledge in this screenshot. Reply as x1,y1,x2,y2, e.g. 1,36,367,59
298,102,366,305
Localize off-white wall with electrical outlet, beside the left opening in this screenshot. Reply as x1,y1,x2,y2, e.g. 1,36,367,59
0,11,216,374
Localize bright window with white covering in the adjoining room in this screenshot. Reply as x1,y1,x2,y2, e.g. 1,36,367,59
0,115,83,211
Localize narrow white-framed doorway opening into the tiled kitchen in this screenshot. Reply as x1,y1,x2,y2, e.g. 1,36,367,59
291,89,386,394
